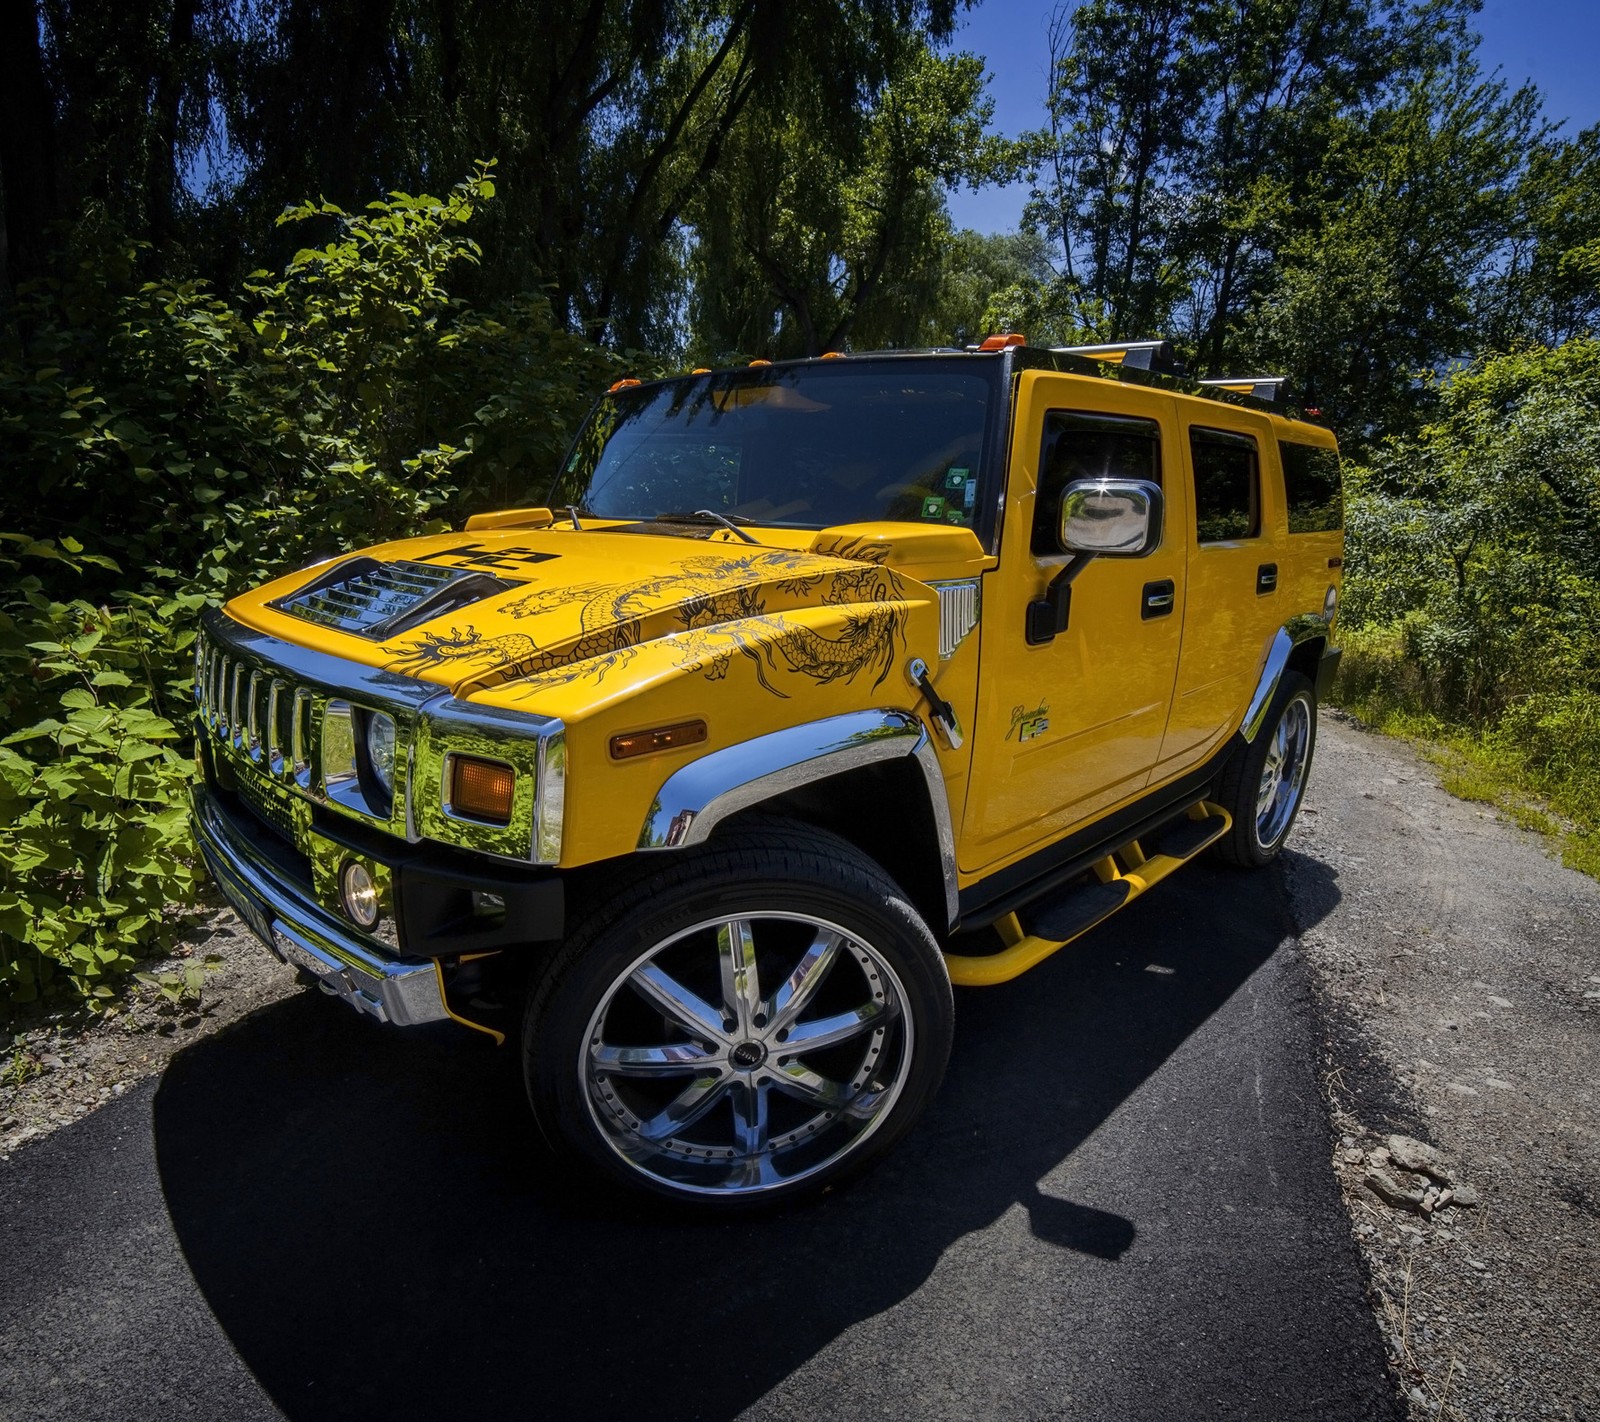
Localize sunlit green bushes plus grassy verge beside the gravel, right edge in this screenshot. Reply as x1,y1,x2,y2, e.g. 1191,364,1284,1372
1336,339,1600,872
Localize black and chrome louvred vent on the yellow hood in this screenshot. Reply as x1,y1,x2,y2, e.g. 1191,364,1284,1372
269,558,518,641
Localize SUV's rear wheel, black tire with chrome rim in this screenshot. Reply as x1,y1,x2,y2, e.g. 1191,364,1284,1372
1216,670,1317,869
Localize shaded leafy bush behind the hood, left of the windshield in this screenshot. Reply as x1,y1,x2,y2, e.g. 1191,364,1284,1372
0,166,619,597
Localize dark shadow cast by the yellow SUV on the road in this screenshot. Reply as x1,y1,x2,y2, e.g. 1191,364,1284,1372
155,867,1337,1419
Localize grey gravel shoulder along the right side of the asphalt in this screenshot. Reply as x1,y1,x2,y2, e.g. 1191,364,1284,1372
1286,712,1600,1422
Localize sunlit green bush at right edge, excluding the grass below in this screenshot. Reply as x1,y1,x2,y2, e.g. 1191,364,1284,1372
1344,339,1600,726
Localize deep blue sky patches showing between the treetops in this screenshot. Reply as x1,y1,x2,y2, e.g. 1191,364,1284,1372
949,0,1600,232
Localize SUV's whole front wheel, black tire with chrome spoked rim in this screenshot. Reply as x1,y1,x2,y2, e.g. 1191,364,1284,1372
522,822,954,1209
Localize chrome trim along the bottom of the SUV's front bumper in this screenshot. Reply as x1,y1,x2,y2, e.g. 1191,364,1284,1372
192,785,450,1027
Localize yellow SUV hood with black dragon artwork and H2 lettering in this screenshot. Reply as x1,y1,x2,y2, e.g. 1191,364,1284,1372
227,521,947,697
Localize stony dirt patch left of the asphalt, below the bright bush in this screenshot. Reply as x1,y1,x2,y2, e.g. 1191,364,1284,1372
0,901,301,1160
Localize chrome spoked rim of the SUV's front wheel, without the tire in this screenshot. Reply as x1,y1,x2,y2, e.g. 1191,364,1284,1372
579,913,915,1196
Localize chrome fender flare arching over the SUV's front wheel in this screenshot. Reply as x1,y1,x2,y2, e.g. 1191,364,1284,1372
638,710,957,928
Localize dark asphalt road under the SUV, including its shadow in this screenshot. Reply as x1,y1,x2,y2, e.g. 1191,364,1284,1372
0,825,1400,1422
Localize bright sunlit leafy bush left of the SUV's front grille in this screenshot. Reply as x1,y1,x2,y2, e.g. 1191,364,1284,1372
0,539,202,1001
